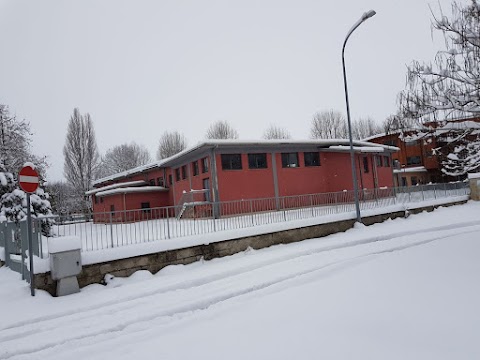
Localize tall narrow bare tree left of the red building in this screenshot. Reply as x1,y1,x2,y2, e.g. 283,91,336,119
63,108,100,210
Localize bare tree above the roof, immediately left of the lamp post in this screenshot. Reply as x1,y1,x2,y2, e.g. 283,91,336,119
310,110,348,139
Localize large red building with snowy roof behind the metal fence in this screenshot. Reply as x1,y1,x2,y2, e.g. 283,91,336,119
87,140,397,220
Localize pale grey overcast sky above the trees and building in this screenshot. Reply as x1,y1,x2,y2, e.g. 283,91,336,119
0,0,454,180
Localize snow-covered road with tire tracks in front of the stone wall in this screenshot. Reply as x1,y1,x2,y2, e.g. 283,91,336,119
0,202,480,360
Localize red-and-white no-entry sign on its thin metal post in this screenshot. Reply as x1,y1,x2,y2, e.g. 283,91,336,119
18,163,38,296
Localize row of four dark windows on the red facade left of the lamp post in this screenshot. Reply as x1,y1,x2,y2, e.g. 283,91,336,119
221,152,320,170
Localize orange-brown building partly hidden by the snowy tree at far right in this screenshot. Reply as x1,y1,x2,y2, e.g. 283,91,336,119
364,118,480,186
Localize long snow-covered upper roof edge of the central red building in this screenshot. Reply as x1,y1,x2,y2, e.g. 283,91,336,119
93,139,399,186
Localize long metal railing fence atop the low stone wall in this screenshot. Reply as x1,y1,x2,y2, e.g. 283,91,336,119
37,182,469,251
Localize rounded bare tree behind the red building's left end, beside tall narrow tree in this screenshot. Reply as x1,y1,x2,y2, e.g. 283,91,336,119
100,142,152,176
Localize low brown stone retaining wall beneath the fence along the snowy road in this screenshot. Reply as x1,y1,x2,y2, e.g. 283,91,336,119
35,201,466,295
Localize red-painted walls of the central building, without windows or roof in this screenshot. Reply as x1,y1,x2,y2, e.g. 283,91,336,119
94,151,393,218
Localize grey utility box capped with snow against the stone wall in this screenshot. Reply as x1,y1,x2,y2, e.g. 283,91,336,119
48,236,82,296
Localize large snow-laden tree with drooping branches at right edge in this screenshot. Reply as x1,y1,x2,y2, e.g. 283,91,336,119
400,0,480,177
